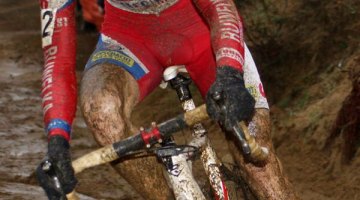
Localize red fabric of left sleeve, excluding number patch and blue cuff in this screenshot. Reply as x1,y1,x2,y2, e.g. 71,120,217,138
40,0,77,141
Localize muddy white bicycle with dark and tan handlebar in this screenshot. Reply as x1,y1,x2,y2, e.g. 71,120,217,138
42,66,268,200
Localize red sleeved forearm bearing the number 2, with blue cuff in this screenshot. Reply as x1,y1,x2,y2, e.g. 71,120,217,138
40,0,76,140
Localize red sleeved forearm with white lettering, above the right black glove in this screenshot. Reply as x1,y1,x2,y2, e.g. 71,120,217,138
194,0,244,72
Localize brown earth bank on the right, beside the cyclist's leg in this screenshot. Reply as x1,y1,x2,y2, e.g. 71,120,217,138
239,0,360,199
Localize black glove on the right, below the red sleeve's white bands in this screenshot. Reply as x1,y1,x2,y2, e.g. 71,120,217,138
206,66,255,131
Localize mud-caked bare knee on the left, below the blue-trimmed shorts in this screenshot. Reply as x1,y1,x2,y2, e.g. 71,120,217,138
80,65,137,145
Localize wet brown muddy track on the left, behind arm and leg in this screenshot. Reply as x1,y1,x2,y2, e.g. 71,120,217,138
0,0,139,199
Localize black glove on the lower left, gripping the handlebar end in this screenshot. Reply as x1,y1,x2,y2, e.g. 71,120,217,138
36,136,77,200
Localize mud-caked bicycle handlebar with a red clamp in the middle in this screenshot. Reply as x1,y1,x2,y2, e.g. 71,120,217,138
66,104,268,200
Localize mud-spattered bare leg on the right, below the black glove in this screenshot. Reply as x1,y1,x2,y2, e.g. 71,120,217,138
229,109,299,200
